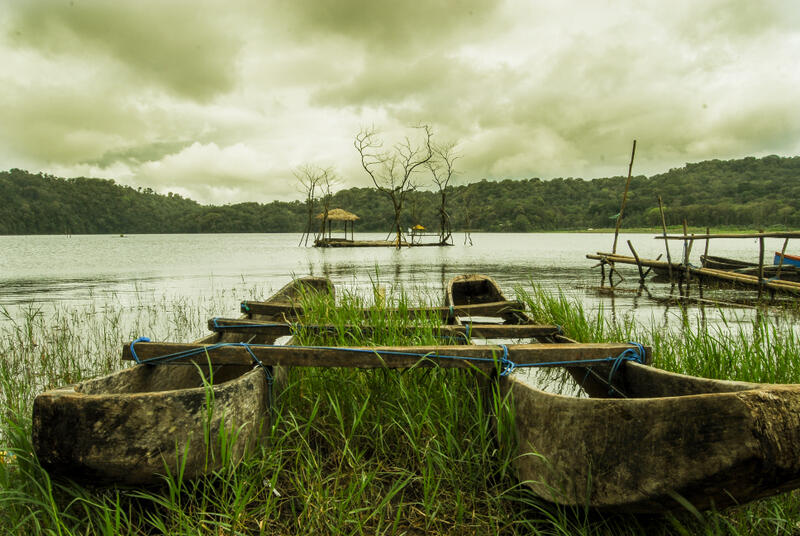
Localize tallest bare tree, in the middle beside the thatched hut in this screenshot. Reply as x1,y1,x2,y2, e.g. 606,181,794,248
353,125,433,248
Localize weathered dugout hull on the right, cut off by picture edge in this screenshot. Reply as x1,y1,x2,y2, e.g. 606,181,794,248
449,276,800,513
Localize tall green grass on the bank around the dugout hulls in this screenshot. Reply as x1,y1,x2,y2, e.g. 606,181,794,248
0,284,800,535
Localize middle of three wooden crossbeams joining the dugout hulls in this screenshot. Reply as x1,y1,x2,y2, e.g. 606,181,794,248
208,318,559,339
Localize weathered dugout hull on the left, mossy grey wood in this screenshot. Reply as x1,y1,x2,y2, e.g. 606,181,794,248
33,278,332,485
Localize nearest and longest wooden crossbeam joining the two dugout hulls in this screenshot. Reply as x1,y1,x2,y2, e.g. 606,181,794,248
122,342,651,370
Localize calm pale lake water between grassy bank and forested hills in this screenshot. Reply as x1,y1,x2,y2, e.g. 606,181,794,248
0,233,782,328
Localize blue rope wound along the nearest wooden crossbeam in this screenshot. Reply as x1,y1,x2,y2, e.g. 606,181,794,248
130,337,646,378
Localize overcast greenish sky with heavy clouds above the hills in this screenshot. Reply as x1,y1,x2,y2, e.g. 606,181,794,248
0,0,800,204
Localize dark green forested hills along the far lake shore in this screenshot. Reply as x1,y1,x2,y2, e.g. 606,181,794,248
0,156,800,234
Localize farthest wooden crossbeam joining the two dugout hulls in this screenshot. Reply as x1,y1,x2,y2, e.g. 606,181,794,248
242,300,524,319
